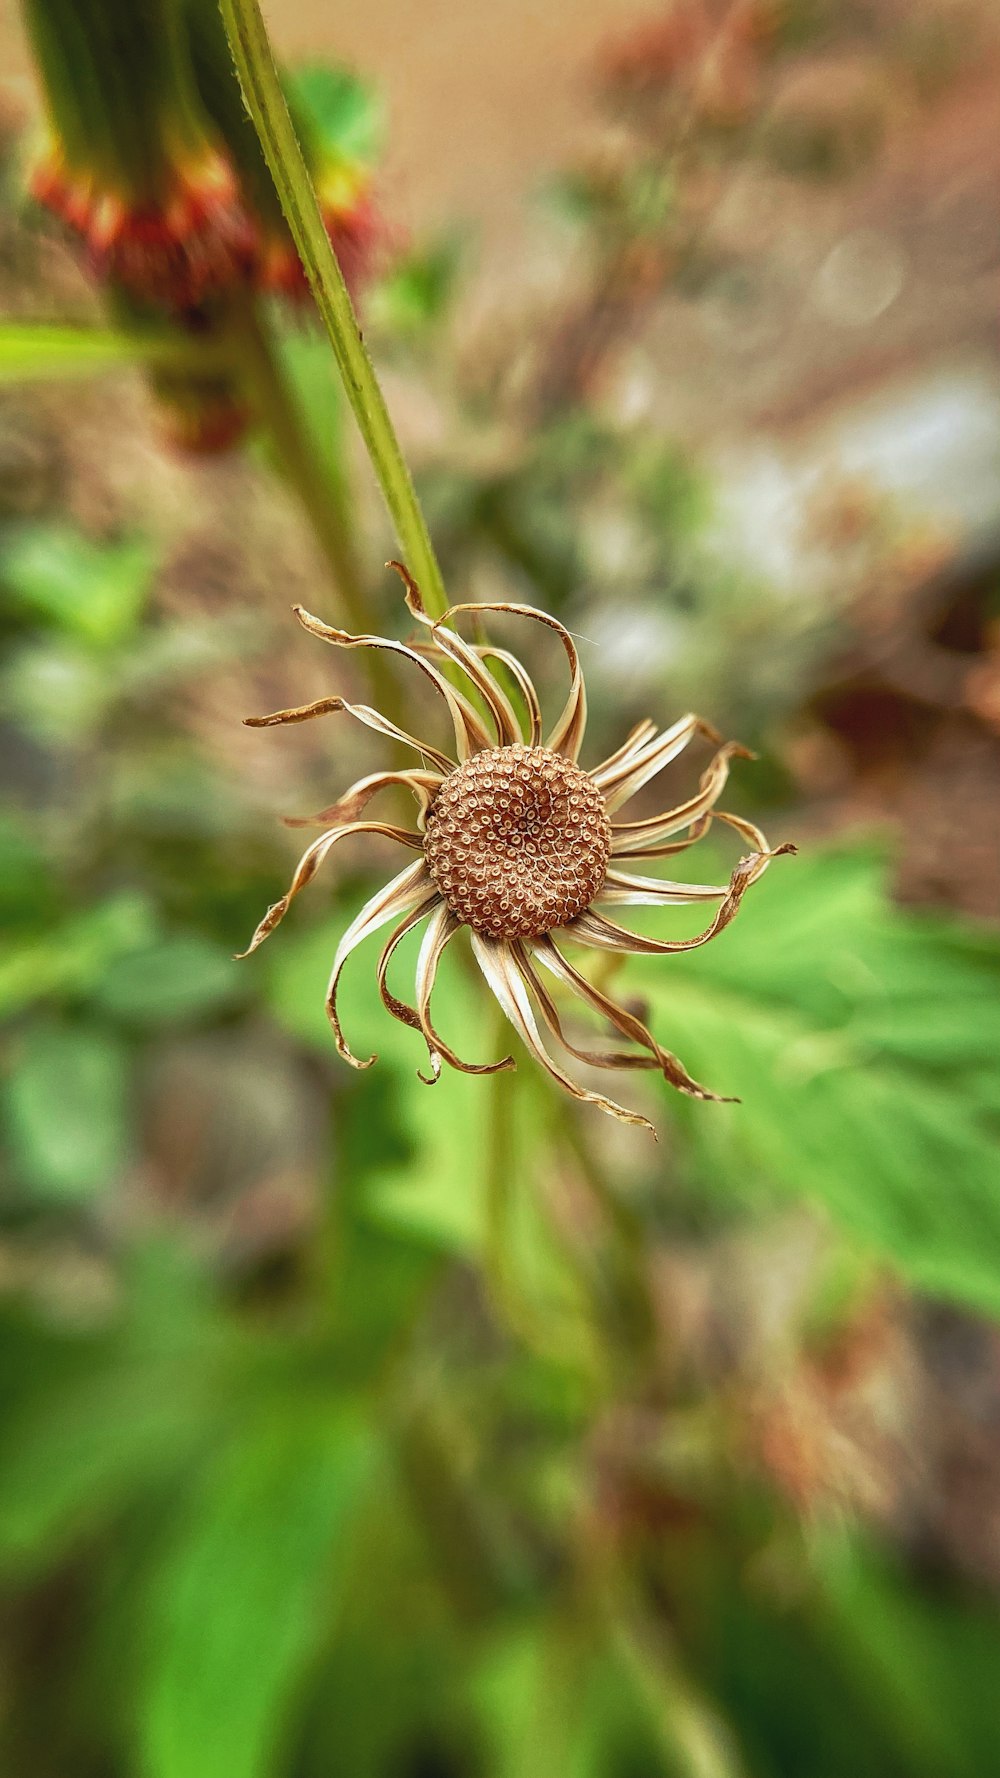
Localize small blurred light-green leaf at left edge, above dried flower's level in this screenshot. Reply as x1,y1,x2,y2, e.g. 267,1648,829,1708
2,525,155,647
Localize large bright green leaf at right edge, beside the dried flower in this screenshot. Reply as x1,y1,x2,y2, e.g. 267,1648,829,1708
630,850,1000,1314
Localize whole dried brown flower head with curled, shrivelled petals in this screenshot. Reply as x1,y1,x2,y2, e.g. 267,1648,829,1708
240,562,795,1129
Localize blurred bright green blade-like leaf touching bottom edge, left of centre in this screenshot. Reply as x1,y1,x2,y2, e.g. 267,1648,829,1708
141,1398,375,1778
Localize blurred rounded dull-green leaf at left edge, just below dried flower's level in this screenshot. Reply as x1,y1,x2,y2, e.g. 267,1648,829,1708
5,1024,130,1202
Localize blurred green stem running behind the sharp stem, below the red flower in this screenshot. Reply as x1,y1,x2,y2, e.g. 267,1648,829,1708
233,304,404,722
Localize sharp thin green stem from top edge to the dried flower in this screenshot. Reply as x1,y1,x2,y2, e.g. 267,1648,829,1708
219,0,448,617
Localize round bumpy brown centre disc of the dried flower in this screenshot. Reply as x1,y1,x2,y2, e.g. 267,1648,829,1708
423,747,610,939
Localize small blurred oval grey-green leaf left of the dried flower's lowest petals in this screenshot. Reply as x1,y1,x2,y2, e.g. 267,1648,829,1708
91,932,247,1026
